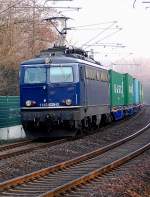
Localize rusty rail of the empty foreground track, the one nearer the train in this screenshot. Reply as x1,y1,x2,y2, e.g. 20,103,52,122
0,123,150,192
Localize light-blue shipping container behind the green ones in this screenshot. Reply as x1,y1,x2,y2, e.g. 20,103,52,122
133,78,140,105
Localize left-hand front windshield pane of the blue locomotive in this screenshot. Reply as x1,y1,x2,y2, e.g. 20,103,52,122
24,67,46,84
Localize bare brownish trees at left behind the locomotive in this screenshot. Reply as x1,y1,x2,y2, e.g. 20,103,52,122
0,0,57,94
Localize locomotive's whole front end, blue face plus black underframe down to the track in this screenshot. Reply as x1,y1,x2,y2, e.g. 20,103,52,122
20,59,81,137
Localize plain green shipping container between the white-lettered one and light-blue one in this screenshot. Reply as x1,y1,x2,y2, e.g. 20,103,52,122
124,73,134,105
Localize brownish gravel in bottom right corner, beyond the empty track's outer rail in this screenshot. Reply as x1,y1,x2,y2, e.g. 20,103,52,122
66,150,150,197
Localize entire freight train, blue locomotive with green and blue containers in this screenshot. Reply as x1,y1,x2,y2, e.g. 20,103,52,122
20,47,143,138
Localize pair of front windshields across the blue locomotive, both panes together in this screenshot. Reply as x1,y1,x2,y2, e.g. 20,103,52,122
22,65,78,84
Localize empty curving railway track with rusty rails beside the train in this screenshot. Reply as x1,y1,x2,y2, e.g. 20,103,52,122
0,123,150,197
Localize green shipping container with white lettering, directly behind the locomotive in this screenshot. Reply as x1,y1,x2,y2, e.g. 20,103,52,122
109,70,124,107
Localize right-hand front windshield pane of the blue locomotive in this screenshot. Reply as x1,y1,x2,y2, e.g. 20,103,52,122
50,66,73,83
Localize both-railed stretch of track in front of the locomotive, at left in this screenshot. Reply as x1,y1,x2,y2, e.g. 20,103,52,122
0,139,67,160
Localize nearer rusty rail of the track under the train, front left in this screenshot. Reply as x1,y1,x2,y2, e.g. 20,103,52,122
0,139,67,160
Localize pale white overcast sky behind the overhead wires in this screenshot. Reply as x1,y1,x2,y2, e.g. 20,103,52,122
45,0,150,61
